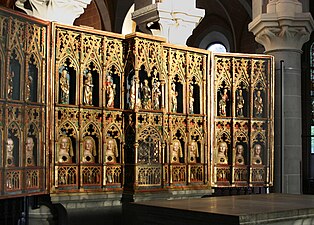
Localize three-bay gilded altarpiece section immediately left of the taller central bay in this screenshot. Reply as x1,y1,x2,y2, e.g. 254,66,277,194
51,24,124,191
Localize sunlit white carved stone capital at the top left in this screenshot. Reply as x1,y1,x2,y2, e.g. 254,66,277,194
15,0,91,25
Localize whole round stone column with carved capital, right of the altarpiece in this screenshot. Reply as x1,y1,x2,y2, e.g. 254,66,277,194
249,0,314,193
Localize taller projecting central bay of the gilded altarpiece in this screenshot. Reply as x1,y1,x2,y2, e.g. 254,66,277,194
124,35,166,189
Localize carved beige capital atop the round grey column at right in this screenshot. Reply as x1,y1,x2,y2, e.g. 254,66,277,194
249,0,314,52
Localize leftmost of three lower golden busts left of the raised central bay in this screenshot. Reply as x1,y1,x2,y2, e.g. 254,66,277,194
58,135,74,163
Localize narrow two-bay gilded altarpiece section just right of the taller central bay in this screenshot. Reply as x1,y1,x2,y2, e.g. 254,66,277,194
165,45,210,188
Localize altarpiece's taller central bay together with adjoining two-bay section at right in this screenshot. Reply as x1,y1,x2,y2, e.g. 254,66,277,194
125,34,209,190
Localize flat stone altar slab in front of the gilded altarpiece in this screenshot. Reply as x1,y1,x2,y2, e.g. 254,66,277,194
123,194,314,225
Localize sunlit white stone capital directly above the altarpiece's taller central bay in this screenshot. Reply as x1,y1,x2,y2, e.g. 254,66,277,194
132,0,205,45
